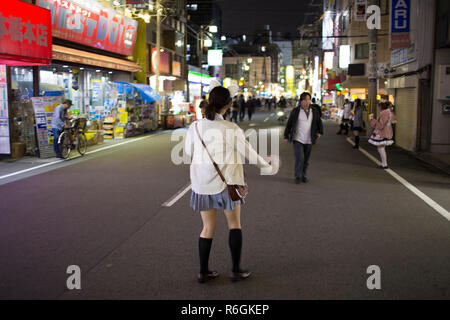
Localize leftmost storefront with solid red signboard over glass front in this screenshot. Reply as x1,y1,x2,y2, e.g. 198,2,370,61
0,0,52,158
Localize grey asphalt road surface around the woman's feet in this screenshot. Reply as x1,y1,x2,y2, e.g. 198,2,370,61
0,113,450,300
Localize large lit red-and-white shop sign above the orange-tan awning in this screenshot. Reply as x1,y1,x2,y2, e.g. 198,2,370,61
36,0,137,56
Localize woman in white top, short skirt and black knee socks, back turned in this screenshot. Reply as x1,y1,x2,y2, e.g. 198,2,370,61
185,87,278,283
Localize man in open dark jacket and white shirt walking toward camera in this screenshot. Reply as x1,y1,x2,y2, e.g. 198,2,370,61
284,92,323,184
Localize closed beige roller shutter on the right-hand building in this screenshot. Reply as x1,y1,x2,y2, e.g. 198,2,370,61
395,88,417,151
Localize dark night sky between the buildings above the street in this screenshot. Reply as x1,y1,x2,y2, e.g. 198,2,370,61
216,0,310,37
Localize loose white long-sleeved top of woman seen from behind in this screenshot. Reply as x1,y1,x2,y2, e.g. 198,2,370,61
185,114,275,195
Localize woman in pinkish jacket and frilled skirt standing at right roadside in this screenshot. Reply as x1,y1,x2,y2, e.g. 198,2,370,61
369,102,396,169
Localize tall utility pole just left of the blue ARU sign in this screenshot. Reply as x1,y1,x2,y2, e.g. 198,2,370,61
368,0,379,121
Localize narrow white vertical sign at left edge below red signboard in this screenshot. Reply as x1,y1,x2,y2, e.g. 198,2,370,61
0,65,11,154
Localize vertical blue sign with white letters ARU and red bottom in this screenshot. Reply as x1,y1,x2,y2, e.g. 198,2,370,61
391,0,411,49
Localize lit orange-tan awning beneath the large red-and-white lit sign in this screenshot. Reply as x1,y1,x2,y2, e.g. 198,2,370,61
53,45,142,72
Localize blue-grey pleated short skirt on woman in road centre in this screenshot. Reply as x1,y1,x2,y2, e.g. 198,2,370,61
191,189,244,211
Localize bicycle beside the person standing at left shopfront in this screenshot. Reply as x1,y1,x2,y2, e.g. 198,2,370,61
58,118,87,159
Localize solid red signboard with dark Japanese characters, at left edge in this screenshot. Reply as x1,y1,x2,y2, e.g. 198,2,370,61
0,0,52,65
